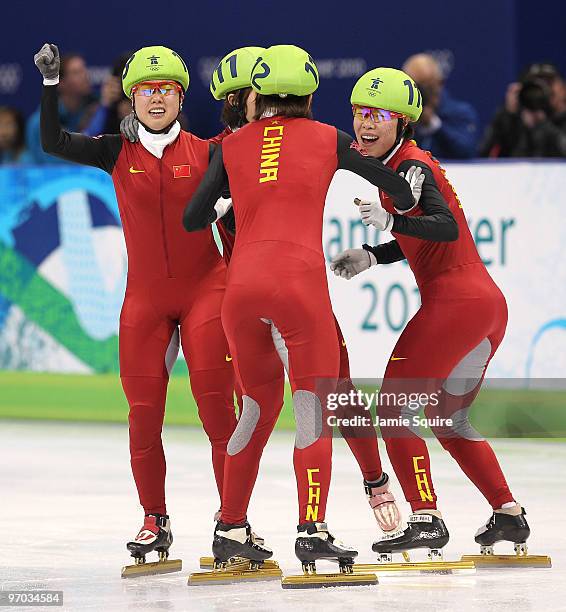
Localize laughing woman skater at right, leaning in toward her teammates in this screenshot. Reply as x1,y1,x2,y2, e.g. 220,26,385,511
331,68,530,559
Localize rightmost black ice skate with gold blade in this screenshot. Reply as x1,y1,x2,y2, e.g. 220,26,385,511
462,504,552,569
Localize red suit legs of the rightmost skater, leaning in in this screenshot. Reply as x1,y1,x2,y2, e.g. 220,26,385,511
379,278,513,511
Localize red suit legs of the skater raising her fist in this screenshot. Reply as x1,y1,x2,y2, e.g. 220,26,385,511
120,267,236,514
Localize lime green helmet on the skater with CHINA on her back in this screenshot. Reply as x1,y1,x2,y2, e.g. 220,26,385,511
251,45,319,97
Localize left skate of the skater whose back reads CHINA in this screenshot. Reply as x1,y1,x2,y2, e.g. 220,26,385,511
188,521,281,586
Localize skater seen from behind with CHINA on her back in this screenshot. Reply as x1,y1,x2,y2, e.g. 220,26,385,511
184,45,424,580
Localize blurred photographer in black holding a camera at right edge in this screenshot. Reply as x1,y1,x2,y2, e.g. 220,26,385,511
480,63,566,157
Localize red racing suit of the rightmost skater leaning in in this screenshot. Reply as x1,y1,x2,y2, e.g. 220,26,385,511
364,141,513,510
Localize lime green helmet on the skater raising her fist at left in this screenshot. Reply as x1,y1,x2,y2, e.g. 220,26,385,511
122,46,189,98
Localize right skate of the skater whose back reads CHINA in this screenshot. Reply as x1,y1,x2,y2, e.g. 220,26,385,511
281,523,377,589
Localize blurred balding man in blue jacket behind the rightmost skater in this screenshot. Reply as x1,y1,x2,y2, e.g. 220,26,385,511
403,53,478,159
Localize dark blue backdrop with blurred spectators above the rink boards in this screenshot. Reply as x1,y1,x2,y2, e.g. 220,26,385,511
0,0,566,164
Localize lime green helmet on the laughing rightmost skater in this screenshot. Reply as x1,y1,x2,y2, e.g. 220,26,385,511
350,68,423,121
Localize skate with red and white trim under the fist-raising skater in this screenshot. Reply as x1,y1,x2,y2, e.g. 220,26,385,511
122,514,183,578
